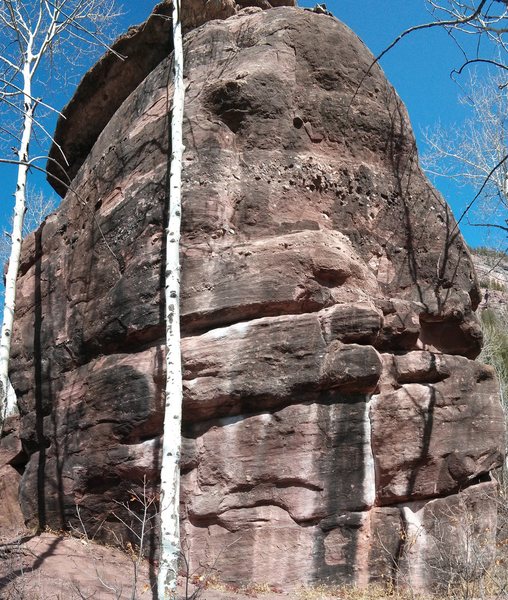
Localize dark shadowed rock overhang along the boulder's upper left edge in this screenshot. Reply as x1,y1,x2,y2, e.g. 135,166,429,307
46,0,295,197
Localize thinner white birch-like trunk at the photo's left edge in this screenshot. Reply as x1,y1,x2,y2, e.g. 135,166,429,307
0,55,35,422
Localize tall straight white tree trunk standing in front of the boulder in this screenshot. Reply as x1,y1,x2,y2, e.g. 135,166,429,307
157,0,184,600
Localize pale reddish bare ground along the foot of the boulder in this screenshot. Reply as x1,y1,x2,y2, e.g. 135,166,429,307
0,531,484,600
